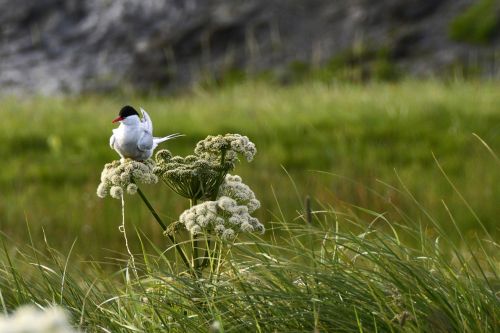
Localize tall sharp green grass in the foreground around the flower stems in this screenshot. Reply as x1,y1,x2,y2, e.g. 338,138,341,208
0,178,500,332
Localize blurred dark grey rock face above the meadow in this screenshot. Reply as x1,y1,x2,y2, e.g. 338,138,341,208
0,0,500,95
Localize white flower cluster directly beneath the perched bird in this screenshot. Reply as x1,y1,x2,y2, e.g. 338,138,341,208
97,159,158,199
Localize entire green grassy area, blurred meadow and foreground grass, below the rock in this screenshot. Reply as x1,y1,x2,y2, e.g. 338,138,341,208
0,81,500,332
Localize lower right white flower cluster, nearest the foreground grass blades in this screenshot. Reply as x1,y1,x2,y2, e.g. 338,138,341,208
179,175,265,240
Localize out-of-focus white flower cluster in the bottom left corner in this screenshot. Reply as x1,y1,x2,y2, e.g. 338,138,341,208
0,305,77,333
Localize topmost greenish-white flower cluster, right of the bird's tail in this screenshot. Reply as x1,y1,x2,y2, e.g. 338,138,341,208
194,134,257,163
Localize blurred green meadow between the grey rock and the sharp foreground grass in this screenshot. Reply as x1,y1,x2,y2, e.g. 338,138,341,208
0,82,500,255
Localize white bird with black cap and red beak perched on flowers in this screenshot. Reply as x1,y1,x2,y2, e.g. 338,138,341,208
109,105,183,161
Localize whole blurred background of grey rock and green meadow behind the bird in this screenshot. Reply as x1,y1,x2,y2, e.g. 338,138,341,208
0,0,500,257
